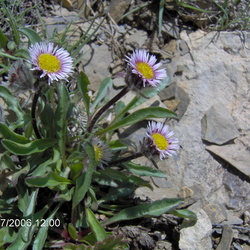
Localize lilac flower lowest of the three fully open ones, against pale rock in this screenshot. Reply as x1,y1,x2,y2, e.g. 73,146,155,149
146,121,180,160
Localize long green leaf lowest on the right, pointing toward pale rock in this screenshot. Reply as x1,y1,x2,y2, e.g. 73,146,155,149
104,199,183,225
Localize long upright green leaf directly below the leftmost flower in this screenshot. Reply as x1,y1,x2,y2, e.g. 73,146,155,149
55,82,70,167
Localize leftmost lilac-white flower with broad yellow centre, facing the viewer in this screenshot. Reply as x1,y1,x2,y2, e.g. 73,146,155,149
29,42,73,84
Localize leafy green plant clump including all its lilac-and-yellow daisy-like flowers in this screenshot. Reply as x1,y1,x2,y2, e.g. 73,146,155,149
0,1,196,249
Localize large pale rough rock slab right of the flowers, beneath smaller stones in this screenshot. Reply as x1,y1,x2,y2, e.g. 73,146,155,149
157,31,250,212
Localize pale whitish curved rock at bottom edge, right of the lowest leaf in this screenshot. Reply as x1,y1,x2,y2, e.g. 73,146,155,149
179,208,212,250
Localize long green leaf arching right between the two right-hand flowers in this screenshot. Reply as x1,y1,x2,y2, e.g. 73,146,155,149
97,107,176,135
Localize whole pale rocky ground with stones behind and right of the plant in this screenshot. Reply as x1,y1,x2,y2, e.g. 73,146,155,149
0,0,250,250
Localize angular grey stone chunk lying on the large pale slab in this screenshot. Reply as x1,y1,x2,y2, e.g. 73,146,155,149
201,104,239,145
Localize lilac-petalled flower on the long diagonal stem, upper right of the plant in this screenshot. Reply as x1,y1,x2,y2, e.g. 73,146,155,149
126,50,167,87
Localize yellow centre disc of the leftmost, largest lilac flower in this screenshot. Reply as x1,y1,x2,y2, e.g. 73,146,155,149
38,54,61,73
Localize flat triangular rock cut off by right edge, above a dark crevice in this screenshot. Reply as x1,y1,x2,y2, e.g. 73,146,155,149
206,144,250,177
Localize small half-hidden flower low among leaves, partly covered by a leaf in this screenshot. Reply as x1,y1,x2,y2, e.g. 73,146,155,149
92,137,113,168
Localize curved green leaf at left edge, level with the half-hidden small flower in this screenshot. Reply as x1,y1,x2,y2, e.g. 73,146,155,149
2,139,56,155
